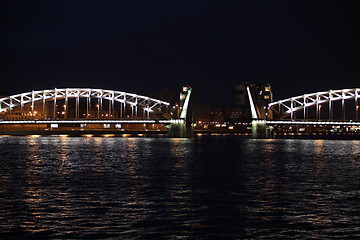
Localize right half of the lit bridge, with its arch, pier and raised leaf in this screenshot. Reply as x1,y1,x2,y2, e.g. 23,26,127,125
247,86,360,138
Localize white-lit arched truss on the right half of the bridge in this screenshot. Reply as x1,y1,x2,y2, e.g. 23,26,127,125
268,88,360,119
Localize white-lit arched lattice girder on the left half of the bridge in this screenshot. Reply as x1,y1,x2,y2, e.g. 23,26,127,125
0,88,170,112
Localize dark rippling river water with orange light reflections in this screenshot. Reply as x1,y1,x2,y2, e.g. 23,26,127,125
0,135,360,239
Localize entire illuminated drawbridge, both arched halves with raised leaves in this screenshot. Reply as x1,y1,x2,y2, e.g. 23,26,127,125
0,84,360,138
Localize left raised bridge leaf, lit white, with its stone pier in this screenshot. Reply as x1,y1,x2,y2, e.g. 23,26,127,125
168,86,197,137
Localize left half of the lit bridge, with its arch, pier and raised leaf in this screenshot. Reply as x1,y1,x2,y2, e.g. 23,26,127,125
0,87,195,137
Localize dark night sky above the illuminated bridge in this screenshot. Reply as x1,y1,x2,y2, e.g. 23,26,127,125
0,0,360,104
